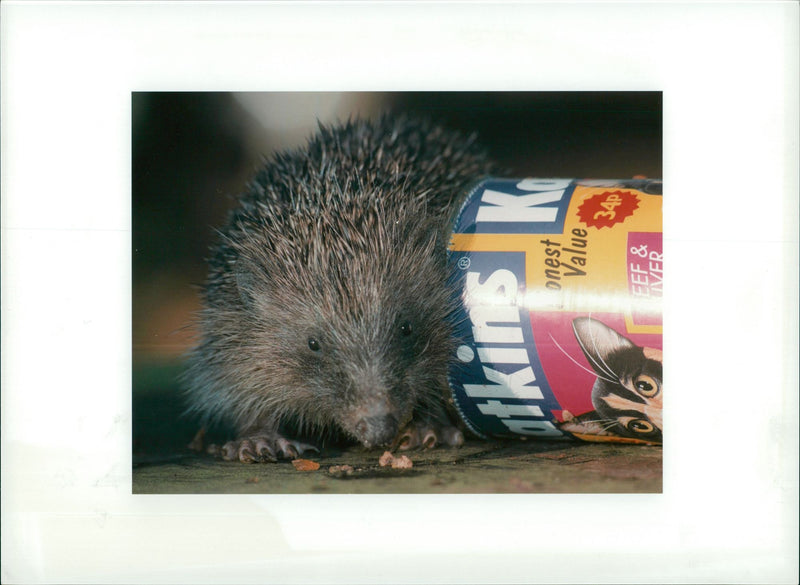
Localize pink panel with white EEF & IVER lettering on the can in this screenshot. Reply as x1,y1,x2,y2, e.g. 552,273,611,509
627,232,664,325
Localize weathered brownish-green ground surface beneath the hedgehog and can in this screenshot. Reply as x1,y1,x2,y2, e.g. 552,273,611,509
133,440,661,494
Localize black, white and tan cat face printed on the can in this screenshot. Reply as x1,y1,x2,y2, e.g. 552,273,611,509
572,317,664,443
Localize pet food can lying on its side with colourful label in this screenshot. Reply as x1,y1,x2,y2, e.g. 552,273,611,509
449,178,663,444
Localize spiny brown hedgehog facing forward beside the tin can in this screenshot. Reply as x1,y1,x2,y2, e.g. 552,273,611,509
184,115,492,463
